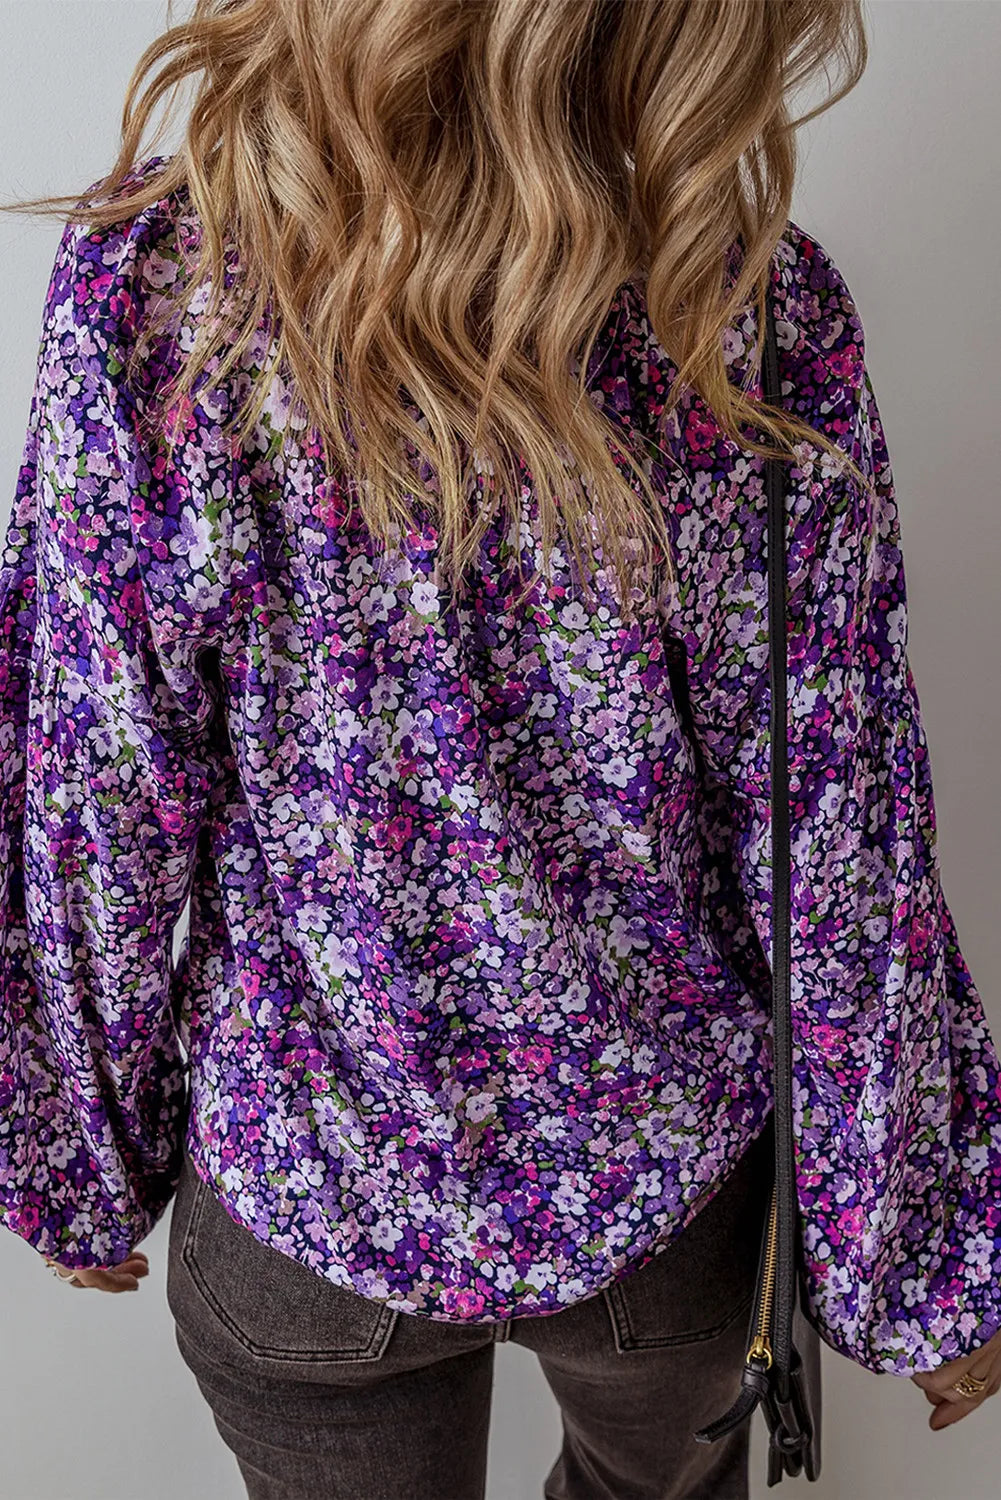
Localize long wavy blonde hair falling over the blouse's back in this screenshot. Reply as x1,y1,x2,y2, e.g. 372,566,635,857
3,0,867,618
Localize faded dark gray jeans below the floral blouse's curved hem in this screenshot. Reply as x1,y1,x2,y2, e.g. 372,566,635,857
167,1116,773,1500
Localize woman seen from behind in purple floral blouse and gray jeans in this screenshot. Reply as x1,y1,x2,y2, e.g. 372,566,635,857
0,0,1001,1500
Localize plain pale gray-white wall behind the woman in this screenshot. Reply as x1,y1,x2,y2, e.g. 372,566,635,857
0,0,1001,1500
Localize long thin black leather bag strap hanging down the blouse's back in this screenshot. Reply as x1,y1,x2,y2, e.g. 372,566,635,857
762,281,798,1394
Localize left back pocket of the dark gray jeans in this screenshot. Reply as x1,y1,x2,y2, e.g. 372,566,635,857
168,1154,399,1368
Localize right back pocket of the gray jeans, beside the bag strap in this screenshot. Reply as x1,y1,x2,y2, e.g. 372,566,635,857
605,1119,774,1353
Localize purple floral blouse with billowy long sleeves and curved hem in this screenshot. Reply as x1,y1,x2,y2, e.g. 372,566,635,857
0,156,1001,1374
